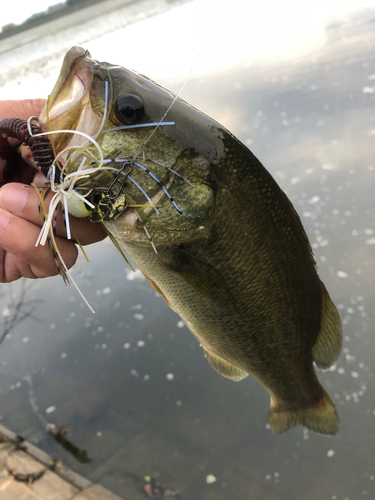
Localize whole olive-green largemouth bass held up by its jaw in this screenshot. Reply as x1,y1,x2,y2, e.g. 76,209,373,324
40,47,341,434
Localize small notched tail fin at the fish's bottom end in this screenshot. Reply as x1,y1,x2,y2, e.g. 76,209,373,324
268,391,339,434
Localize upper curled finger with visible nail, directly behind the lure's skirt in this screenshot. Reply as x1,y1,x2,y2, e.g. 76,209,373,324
0,183,106,245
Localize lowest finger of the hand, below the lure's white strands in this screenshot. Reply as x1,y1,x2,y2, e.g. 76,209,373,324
0,210,78,283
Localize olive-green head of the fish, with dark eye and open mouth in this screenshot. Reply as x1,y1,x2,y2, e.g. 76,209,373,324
39,47,226,240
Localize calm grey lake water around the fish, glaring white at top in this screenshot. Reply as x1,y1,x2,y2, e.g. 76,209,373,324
0,0,375,500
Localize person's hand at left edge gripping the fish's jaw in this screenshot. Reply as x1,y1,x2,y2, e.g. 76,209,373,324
0,99,106,283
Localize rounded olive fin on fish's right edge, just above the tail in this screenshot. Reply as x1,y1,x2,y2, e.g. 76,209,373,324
312,282,342,370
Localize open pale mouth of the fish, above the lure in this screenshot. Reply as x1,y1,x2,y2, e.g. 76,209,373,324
39,47,102,163
